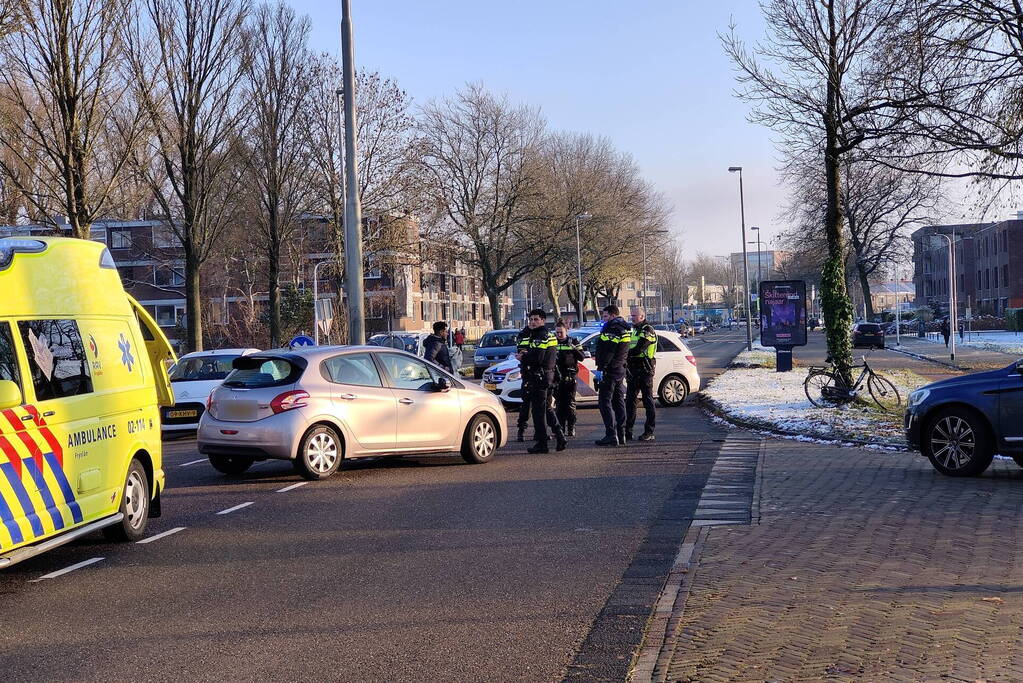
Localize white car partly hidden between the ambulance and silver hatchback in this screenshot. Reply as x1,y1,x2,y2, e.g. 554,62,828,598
161,349,259,435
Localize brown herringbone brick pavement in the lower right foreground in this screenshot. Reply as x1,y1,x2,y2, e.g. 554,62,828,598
654,440,1023,681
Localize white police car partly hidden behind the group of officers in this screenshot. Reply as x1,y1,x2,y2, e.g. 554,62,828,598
483,329,700,407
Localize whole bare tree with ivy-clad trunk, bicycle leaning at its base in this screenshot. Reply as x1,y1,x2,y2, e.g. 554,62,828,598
723,0,919,378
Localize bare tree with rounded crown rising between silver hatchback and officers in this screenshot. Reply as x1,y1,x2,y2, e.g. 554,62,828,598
417,84,553,327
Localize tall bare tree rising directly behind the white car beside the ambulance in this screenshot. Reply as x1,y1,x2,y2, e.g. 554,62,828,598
126,0,249,350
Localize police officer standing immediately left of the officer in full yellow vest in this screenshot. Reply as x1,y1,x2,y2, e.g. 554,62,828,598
595,305,632,446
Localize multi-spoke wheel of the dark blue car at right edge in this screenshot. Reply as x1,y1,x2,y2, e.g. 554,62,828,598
923,408,994,476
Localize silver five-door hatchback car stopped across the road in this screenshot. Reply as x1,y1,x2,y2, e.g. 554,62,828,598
198,347,507,480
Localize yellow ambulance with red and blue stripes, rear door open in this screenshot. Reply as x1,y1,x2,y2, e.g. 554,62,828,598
0,237,174,567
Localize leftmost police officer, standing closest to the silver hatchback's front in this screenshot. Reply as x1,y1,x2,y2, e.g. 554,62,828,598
516,309,568,453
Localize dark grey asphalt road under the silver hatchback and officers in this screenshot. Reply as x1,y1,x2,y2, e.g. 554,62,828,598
0,332,741,681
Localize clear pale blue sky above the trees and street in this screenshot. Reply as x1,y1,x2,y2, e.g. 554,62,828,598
291,0,785,258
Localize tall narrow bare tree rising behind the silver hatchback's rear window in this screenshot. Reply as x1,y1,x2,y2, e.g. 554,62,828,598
244,2,313,346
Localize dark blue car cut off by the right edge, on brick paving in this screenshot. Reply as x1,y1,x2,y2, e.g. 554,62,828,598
905,360,1023,476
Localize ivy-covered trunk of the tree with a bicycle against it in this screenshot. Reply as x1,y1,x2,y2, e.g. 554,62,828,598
820,3,852,385
